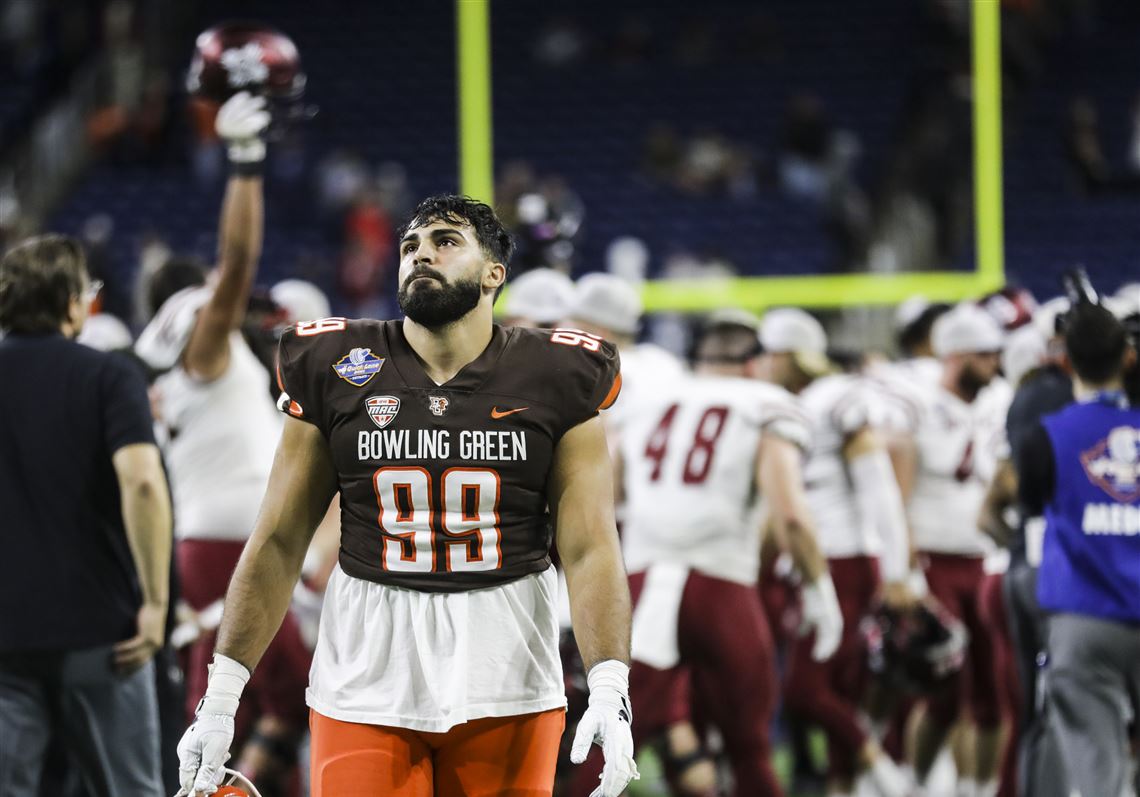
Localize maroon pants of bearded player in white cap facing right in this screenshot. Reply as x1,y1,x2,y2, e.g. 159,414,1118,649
922,552,1001,730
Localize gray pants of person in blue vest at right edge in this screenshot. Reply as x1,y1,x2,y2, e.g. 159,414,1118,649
1045,615,1140,797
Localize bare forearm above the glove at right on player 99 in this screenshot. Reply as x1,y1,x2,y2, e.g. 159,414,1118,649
562,537,632,672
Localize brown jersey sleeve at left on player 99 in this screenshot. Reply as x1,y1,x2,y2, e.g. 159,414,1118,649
277,318,347,433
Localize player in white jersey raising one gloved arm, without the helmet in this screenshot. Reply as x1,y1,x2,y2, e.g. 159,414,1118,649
136,92,310,783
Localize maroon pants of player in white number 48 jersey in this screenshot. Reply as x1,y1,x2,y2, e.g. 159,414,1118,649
570,571,783,797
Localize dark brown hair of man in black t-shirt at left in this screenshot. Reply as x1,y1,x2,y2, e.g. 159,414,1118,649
0,235,88,335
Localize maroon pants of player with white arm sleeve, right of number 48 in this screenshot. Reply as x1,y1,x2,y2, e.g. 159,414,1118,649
784,556,879,778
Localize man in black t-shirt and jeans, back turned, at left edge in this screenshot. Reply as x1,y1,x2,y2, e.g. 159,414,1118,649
0,235,171,797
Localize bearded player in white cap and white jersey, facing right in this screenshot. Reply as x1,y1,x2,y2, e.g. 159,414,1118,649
902,303,1008,795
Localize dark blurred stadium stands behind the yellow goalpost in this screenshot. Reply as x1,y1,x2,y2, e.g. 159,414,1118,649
0,0,1126,330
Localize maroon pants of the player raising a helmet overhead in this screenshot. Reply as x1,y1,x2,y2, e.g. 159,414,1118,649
177,539,312,750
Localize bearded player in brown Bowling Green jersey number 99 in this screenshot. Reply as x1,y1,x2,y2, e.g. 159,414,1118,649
179,196,637,797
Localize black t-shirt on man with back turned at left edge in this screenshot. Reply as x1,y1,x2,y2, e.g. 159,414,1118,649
0,334,154,653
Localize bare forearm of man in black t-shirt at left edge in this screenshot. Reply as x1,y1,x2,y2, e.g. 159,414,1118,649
121,469,172,608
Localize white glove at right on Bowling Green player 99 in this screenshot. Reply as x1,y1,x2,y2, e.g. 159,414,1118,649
570,659,641,797
